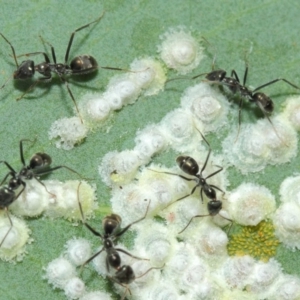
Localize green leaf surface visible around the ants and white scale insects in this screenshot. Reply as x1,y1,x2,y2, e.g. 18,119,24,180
0,0,300,300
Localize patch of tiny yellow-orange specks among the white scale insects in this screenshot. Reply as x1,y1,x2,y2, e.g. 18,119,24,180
227,220,280,262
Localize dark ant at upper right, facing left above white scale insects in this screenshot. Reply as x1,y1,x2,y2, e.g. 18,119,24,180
169,38,300,140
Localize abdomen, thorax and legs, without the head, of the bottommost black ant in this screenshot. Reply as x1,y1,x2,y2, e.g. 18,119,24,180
77,183,151,271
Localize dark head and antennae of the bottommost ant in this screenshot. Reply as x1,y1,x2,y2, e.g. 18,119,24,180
108,265,165,300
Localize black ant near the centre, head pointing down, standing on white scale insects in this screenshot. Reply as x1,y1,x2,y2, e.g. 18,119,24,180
152,129,232,234
